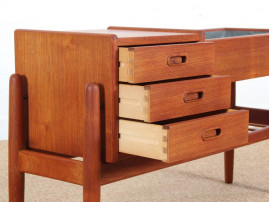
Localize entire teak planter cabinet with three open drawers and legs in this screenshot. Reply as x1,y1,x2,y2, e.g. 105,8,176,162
9,27,269,202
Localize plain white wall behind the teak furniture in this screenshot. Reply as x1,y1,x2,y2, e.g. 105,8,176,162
0,0,270,140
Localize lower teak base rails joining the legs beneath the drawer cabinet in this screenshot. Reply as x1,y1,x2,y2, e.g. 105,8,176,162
19,121,269,185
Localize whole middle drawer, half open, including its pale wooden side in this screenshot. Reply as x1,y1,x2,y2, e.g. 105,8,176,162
119,76,231,122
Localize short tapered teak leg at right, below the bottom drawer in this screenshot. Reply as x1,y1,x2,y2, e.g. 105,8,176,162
224,150,234,183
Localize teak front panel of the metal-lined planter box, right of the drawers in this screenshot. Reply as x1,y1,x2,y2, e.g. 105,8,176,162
206,34,269,82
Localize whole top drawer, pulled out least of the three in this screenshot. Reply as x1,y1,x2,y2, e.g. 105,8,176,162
119,42,215,83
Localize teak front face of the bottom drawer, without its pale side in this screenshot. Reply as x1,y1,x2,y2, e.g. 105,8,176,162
167,110,249,162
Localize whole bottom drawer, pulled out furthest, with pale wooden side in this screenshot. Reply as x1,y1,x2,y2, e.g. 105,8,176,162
119,110,249,163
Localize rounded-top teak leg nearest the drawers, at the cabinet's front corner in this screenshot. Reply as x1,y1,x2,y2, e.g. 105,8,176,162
83,83,101,202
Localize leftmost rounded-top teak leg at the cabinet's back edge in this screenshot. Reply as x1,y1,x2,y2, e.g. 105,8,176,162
8,74,25,202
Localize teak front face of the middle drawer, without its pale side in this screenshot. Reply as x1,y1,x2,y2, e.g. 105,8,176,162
147,76,231,122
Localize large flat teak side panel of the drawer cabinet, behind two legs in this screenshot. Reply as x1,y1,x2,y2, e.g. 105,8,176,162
15,30,118,162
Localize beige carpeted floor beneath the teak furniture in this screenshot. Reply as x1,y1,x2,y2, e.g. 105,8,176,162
0,140,269,202
